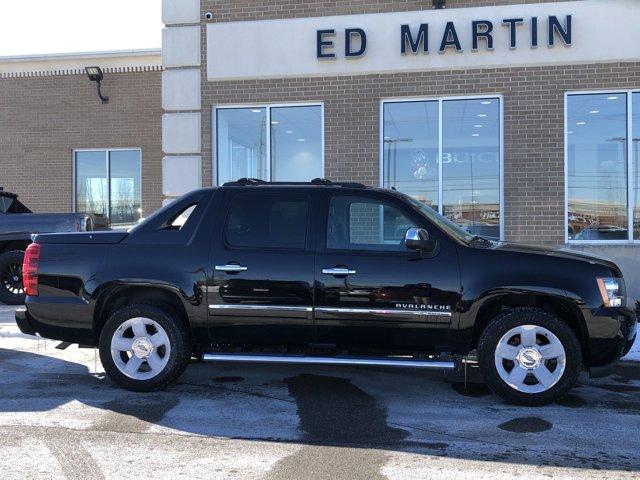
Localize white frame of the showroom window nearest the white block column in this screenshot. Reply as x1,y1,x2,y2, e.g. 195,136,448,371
211,102,325,186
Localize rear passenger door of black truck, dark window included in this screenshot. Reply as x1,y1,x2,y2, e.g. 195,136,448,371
208,187,315,346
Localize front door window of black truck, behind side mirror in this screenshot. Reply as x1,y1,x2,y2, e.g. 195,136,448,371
327,197,416,251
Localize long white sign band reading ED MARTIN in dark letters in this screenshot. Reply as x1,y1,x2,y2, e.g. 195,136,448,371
207,0,640,81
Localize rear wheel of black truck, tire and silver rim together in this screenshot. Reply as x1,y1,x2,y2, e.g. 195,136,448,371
99,304,191,392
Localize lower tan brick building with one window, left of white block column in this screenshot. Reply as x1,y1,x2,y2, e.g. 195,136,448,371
0,50,163,224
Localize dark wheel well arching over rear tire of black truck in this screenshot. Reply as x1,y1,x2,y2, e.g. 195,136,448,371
93,286,189,344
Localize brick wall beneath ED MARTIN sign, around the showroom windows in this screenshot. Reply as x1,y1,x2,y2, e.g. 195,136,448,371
203,62,640,244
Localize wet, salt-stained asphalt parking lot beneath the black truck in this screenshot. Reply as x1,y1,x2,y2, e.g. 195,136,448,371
0,305,640,480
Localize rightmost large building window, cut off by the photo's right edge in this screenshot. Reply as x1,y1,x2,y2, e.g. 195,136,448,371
566,92,640,242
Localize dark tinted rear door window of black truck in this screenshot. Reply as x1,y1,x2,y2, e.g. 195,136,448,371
225,194,309,249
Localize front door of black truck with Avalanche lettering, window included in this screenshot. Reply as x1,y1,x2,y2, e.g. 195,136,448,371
315,192,460,350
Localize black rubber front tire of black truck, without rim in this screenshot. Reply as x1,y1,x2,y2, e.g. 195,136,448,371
478,308,582,406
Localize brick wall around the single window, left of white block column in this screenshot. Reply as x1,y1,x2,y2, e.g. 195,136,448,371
0,71,163,215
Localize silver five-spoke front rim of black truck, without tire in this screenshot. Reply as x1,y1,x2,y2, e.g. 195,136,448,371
495,325,567,393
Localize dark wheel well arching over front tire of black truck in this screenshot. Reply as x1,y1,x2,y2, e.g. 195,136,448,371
472,293,588,358
